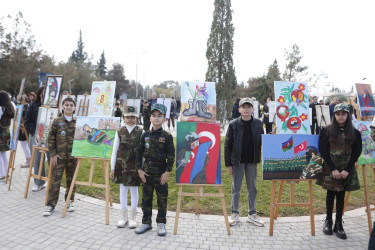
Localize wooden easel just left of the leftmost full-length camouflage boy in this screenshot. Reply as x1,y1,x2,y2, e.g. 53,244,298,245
24,146,52,206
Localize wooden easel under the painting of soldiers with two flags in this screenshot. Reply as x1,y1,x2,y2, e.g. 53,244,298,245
269,179,315,236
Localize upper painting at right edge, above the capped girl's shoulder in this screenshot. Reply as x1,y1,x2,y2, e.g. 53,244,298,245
355,83,375,117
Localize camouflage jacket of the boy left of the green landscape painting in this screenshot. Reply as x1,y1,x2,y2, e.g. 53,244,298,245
48,116,76,159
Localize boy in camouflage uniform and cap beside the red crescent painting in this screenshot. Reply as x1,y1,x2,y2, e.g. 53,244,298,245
135,103,174,236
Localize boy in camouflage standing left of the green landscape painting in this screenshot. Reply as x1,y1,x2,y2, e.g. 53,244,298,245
43,97,76,216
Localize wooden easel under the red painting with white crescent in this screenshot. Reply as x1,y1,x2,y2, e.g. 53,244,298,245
173,183,231,235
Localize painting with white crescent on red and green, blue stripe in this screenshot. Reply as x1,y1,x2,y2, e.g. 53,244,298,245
176,122,221,184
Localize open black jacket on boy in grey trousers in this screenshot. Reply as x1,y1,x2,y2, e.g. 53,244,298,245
224,117,264,167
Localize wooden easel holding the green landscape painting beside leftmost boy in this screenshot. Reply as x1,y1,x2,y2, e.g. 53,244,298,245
62,157,112,225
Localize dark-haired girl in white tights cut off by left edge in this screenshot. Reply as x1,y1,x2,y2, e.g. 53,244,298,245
0,90,16,180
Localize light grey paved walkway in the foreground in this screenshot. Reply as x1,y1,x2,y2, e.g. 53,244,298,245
0,143,375,250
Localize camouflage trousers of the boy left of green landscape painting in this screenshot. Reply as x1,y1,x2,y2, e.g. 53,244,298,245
47,158,77,207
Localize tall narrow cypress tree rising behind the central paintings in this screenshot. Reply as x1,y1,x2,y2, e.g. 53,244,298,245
206,0,236,125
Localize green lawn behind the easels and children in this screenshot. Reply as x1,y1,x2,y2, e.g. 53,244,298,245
63,137,375,217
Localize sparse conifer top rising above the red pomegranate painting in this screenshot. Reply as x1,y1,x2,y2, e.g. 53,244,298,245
283,44,308,82
